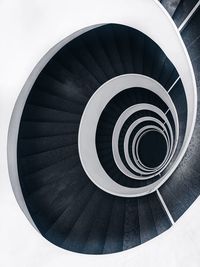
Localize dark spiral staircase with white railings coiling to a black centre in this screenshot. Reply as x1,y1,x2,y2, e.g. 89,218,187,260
7,0,200,254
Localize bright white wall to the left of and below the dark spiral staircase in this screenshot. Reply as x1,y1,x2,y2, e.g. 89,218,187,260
0,0,200,267
